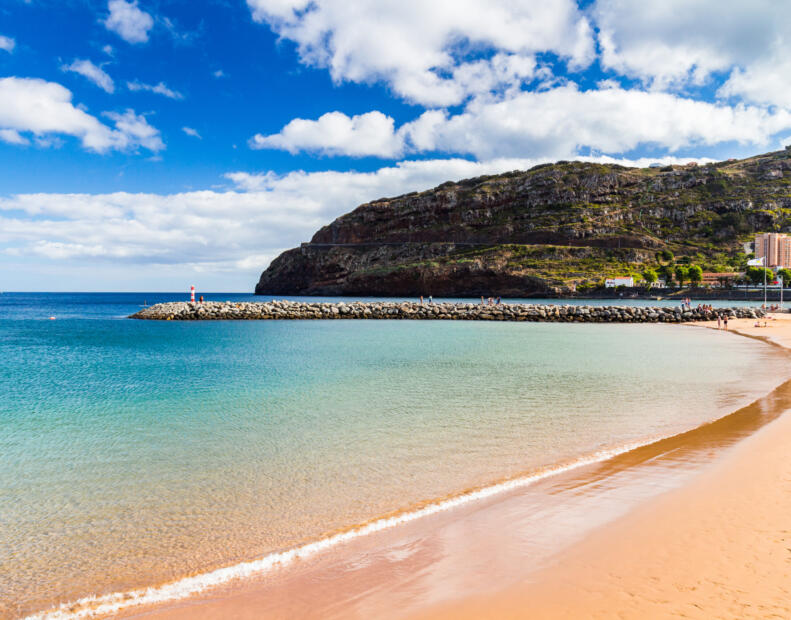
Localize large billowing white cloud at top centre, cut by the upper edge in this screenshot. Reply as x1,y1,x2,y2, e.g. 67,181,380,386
247,0,594,106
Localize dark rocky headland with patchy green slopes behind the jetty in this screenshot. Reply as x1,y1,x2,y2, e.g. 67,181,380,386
256,151,791,296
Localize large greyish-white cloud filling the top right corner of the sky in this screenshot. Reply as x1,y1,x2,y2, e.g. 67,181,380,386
591,0,791,97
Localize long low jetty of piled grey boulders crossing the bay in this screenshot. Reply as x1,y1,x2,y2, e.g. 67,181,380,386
130,301,763,323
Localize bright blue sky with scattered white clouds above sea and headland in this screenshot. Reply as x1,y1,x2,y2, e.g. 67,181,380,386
0,0,791,292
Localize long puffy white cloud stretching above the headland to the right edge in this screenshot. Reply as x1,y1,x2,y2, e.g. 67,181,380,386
251,83,791,159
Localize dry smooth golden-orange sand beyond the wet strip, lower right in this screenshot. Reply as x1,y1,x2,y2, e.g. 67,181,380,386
415,315,791,619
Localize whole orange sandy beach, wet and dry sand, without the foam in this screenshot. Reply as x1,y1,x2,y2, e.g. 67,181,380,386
120,317,791,619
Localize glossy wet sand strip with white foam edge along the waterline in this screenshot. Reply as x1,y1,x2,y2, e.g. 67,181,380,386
20,319,791,618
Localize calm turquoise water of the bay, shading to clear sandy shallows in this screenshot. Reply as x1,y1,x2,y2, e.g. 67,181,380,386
0,293,789,616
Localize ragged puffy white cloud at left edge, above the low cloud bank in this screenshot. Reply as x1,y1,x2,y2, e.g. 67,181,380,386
0,77,164,153
